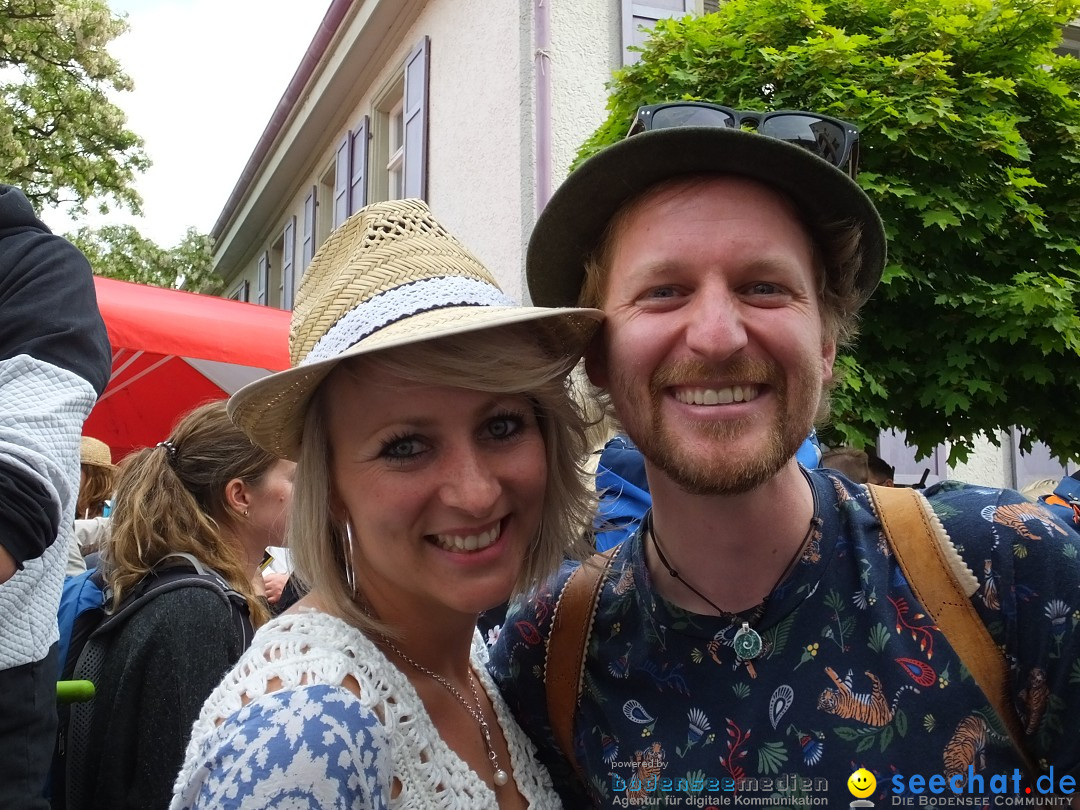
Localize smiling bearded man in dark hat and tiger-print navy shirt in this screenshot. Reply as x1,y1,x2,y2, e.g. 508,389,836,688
492,103,1080,808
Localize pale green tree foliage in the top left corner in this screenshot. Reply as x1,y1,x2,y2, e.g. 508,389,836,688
0,0,149,214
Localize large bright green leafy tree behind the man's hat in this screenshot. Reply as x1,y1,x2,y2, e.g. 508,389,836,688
578,0,1080,459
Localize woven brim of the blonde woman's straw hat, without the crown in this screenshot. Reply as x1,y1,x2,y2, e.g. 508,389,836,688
228,306,604,461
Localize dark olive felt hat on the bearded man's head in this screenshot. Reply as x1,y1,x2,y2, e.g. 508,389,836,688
525,126,886,307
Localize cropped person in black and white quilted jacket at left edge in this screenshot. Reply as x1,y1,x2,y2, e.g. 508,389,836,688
0,185,111,808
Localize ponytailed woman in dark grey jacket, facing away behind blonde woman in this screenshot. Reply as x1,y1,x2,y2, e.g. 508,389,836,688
83,402,295,808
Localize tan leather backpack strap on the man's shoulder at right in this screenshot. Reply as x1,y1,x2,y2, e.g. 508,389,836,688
867,484,1039,775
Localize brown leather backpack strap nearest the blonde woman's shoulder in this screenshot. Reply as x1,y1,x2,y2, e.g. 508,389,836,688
544,545,619,781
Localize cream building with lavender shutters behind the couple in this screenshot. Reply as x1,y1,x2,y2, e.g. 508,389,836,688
212,0,1080,487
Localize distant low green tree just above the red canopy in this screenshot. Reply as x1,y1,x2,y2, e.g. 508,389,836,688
67,225,221,294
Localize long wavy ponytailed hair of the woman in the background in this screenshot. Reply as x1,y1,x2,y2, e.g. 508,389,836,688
105,402,278,626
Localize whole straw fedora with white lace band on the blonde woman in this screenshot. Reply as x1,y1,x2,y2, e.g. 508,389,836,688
229,200,603,460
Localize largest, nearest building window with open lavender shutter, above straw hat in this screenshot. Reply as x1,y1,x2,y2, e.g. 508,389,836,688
373,37,430,200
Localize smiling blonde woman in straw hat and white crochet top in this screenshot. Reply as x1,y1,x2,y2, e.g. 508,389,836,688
173,200,599,808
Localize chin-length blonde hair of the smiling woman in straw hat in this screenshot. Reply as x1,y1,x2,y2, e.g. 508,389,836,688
289,325,595,633
